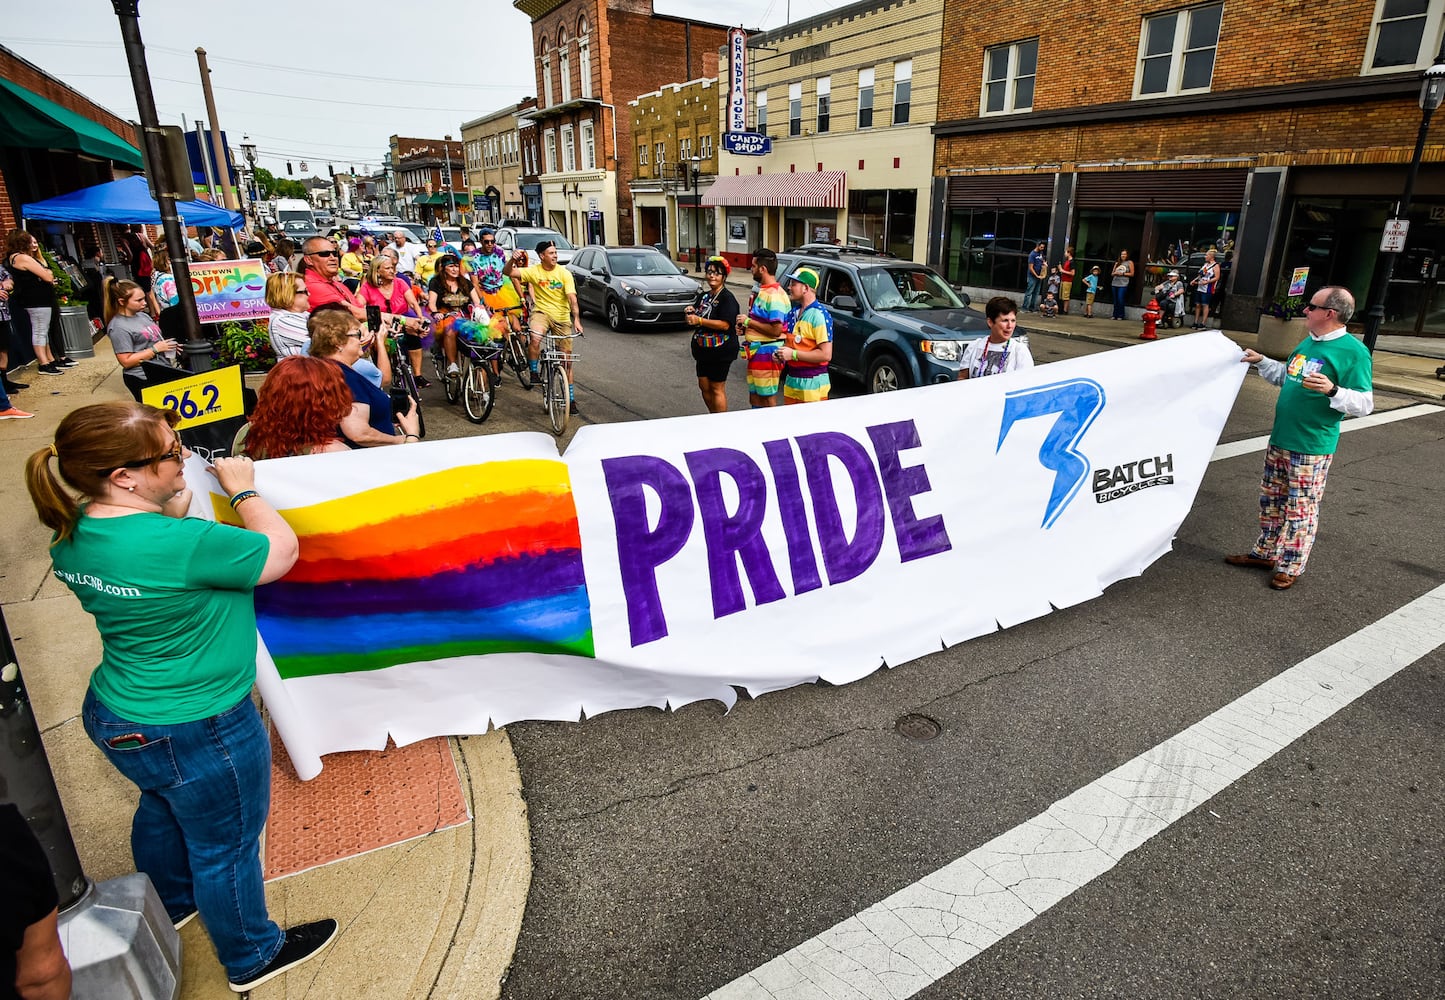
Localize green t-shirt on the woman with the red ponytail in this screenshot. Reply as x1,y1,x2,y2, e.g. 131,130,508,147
51,513,270,724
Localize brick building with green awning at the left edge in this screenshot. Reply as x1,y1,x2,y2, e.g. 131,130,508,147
0,46,142,262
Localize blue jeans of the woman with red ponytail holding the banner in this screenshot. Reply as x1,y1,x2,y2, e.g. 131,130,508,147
81,691,285,981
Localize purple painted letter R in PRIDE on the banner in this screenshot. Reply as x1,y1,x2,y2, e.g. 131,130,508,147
683,448,786,618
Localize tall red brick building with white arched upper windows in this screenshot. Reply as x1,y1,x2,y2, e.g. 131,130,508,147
512,0,727,244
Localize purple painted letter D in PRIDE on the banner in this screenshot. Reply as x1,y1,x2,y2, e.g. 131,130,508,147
798,431,883,585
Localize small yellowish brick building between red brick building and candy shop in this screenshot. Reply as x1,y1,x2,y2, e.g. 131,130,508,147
627,78,723,260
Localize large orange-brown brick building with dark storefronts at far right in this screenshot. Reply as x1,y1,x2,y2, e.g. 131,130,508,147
929,0,1445,332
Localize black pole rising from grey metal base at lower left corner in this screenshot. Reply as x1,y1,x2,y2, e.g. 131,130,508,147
0,611,85,910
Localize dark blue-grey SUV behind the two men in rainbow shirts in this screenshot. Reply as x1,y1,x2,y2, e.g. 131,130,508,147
779,254,988,393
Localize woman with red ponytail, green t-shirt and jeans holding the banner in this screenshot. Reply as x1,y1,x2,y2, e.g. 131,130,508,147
26,402,337,991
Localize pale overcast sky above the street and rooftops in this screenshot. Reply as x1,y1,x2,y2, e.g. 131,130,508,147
0,0,851,176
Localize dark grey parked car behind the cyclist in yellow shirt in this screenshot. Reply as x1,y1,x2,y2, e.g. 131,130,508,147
566,246,702,329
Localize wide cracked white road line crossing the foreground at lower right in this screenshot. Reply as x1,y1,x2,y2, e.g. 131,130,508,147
704,585,1445,1000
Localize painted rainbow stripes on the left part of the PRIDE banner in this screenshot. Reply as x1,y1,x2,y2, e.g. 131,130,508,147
236,460,594,678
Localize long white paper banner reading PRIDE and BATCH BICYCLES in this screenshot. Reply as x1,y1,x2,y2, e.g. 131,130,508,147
209,334,1247,777
